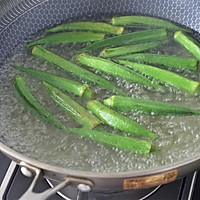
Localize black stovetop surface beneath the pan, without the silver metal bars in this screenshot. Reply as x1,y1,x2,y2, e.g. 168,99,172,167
0,152,200,200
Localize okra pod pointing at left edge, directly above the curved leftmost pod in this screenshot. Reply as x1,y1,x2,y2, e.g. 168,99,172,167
14,66,93,99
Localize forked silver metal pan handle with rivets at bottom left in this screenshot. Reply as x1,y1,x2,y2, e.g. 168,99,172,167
19,162,93,200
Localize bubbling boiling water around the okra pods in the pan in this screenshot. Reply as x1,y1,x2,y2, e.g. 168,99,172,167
0,27,200,172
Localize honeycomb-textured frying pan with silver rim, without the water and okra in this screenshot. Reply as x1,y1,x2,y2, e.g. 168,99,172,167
0,0,200,199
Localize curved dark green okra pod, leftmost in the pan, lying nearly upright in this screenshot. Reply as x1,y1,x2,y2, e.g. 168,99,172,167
14,75,66,130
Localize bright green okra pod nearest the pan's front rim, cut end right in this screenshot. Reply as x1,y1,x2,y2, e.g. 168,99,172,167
68,128,152,155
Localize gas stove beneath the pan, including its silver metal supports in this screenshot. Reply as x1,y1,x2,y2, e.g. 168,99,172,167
0,152,200,200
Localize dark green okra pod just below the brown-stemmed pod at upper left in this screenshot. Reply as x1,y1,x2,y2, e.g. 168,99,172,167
27,31,105,47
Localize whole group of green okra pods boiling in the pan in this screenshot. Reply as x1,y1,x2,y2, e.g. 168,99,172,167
14,16,200,155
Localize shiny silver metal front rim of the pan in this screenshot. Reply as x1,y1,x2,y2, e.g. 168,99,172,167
0,141,200,179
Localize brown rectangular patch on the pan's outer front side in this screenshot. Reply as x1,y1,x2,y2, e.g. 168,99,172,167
123,170,178,190
